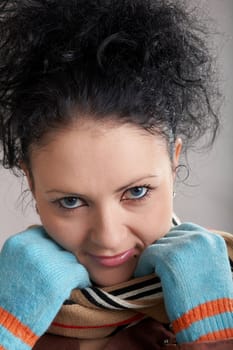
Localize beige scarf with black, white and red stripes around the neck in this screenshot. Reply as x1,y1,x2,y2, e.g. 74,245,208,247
48,228,233,339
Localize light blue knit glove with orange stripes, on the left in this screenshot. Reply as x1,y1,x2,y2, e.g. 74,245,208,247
0,226,90,350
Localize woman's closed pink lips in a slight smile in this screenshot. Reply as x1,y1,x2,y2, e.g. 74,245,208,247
90,249,136,267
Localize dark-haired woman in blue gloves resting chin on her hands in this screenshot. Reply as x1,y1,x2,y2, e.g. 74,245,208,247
0,0,233,350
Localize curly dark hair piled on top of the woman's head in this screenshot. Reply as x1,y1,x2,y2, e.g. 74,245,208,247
0,0,219,173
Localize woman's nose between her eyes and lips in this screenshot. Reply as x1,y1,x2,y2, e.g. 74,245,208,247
89,205,128,250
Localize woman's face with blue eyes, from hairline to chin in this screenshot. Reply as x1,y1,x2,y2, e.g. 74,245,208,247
26,119,181,286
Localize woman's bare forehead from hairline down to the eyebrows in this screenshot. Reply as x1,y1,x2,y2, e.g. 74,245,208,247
28,121,170,194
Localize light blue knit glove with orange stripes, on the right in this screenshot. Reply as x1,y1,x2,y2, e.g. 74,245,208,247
135,223,233,343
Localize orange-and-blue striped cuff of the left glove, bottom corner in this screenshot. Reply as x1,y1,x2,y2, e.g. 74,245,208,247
0,307,39,350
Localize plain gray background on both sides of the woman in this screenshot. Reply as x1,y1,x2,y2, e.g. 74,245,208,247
0,0,233,246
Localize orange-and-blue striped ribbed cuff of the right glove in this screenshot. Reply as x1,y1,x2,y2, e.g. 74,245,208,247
172,298,233,343
